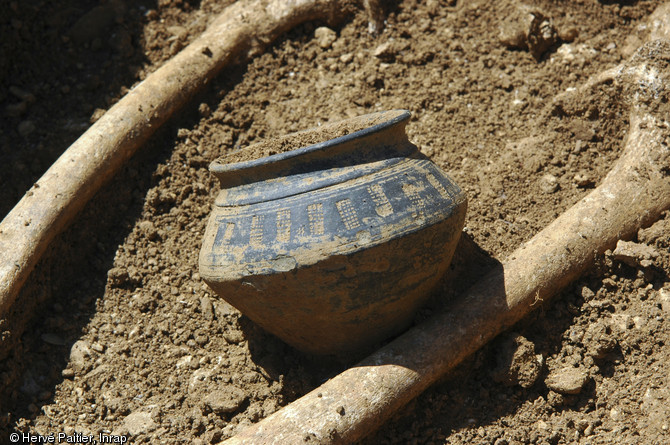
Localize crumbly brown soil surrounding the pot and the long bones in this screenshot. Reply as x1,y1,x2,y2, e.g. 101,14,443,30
0,0,670,445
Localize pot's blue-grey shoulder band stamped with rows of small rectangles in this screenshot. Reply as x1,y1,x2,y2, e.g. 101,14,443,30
200,158,467,282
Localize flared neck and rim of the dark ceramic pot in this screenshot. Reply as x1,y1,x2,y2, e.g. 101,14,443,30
210,110,421,206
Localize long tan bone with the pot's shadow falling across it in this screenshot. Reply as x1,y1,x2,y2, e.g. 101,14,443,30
223,42,670,445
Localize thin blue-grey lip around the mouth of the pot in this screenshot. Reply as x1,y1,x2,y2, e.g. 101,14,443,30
209,109,411,175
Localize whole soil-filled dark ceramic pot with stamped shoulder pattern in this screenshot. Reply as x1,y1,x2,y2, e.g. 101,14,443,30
200,110,467,355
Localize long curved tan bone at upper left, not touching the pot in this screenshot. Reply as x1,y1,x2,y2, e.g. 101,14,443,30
0,0,350,346
